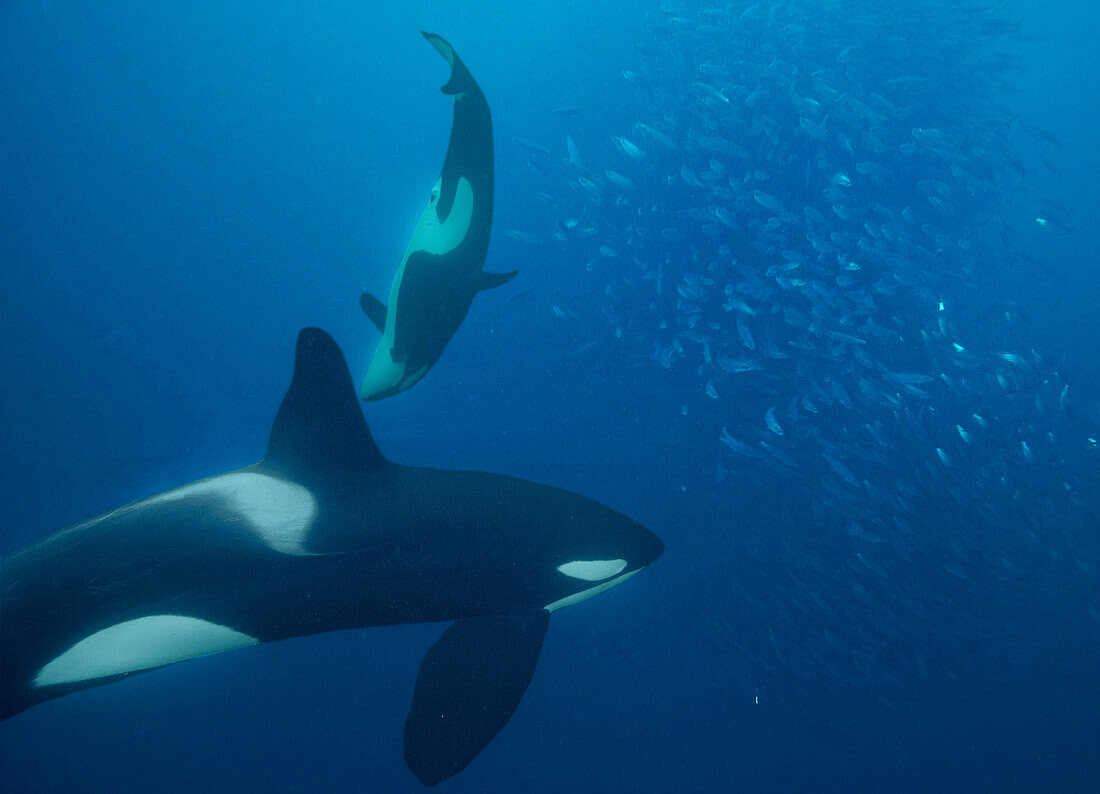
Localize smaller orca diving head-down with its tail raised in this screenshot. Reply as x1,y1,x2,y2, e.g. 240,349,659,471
360,33,516,400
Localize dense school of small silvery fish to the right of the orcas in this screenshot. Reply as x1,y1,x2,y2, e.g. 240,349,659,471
508,0,1100,685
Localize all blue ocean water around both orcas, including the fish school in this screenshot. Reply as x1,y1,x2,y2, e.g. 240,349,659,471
0,0,1100,792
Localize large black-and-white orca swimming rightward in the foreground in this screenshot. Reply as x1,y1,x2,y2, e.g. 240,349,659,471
0,329,663,785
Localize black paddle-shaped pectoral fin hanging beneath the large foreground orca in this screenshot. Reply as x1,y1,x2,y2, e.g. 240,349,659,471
405,609,550,785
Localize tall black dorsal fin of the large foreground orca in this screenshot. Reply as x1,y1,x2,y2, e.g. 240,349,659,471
263,328,386,477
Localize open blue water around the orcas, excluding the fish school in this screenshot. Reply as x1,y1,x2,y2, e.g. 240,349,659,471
0,0,1100,792
